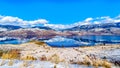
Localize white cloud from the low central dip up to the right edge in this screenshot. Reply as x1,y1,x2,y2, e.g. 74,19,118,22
44,15,120,30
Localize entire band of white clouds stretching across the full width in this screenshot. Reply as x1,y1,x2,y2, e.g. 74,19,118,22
0,15,120,30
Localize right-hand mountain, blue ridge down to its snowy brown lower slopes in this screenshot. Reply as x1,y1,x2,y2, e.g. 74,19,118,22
63,22,120,35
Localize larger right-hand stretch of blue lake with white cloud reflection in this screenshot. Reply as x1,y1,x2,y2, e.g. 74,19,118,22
45,35,120,47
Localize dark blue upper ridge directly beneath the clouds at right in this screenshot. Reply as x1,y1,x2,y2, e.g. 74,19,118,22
65,22,120,31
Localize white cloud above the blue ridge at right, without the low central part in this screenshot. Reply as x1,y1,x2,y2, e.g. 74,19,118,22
73,15,120,26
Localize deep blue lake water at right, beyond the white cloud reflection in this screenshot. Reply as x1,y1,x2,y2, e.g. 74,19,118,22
73,35,120,44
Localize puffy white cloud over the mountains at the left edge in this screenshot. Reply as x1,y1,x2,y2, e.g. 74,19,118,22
0,15,48,26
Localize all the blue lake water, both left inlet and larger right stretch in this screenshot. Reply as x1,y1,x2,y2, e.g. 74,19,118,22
0,35,120,47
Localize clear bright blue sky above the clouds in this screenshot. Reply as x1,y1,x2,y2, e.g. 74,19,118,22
0,0,120,24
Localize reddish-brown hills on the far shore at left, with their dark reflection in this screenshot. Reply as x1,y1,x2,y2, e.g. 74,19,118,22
0,28,71,39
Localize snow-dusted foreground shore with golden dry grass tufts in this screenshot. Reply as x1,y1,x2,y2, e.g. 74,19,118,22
0,41,120,68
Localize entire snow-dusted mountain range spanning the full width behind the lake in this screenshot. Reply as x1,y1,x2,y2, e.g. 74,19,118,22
0,22,120,39
